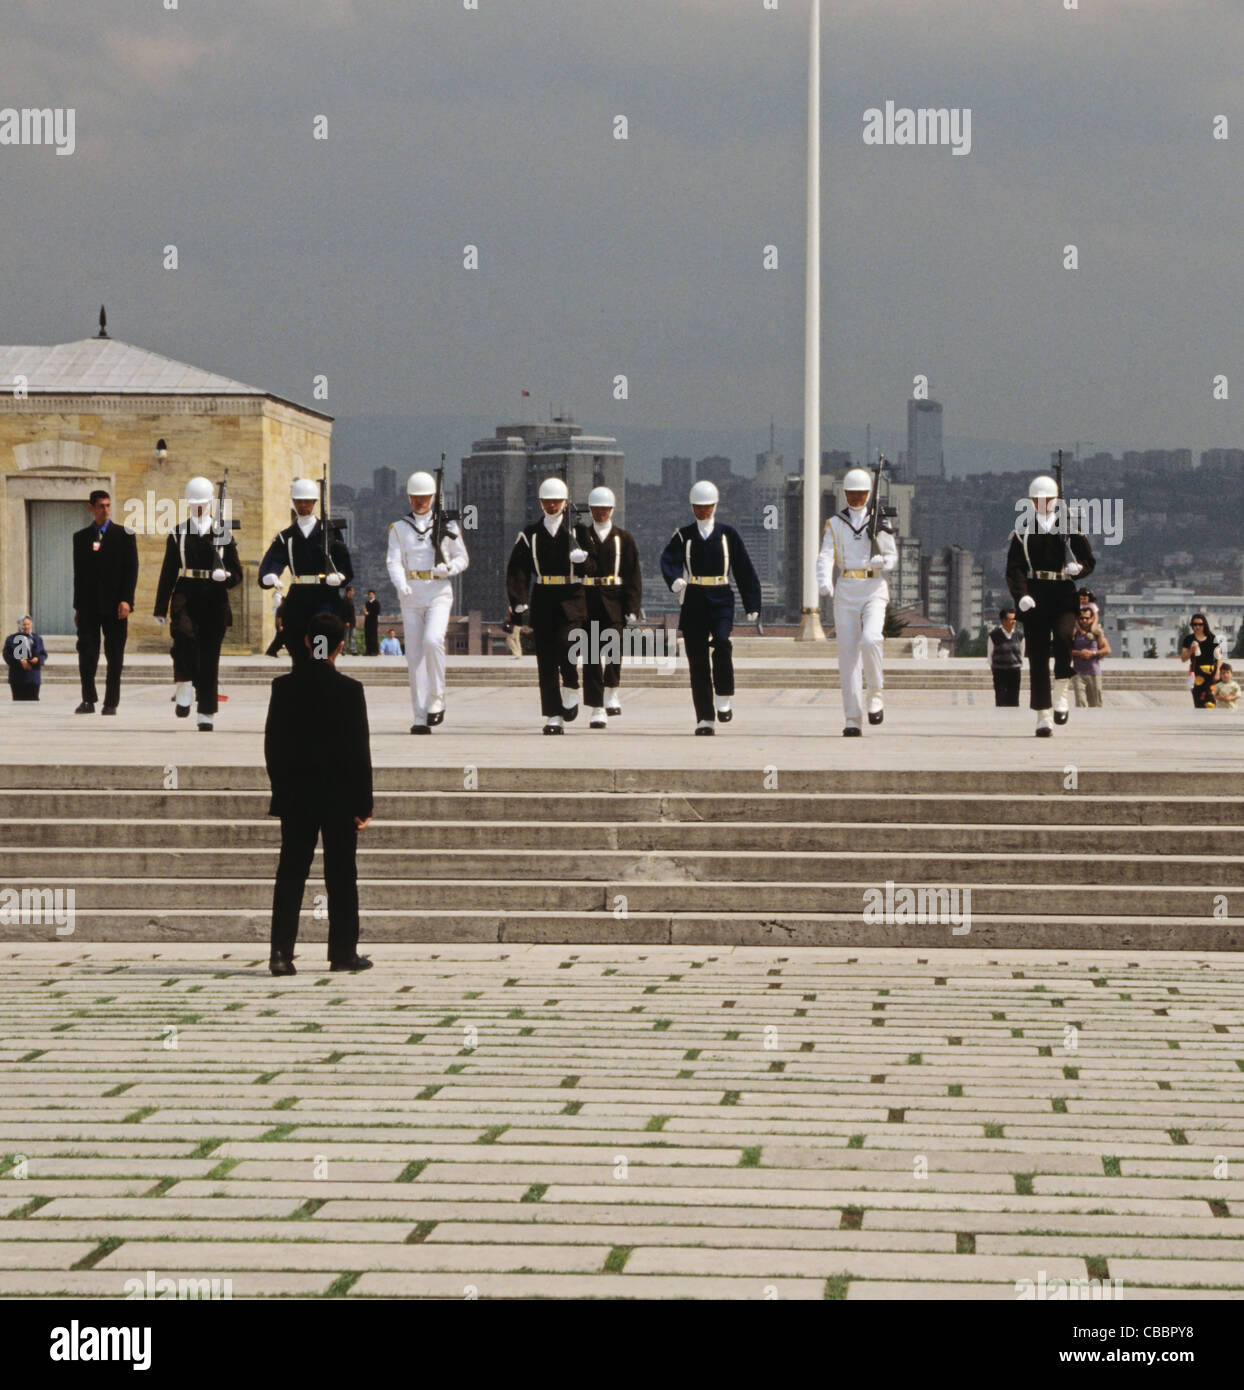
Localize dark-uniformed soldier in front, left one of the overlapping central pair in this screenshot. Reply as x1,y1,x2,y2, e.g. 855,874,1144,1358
506,478,596,734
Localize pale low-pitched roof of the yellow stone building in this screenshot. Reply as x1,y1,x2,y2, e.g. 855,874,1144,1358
0,338,329,420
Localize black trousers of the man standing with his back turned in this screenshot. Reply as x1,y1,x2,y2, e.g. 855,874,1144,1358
272,812,359,962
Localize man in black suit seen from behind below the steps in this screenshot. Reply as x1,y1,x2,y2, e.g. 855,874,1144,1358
264,613,371,974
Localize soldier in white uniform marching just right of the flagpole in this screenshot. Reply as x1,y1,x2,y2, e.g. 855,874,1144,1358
816,468,898,738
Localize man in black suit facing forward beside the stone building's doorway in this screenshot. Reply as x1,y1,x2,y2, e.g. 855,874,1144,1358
74,488,138,714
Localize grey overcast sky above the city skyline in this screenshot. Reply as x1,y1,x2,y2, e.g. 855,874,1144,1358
0,0,1244,467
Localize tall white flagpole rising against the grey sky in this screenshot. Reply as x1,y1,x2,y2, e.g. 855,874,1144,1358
799,0,826,642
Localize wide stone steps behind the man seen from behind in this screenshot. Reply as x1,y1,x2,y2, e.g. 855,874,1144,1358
0,763,1244,949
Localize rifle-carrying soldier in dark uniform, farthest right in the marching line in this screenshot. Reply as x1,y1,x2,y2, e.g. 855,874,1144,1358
1006,474,1097,738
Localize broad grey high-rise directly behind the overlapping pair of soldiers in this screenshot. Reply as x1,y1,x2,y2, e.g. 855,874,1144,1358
461,416,627,623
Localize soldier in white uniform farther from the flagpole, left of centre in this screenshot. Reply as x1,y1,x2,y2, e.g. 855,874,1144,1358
385,473,468,734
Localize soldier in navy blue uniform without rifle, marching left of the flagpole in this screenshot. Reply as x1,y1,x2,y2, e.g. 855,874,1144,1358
660,482,760,734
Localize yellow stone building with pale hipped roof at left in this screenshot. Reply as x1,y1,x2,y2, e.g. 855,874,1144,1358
0,328,330,653
